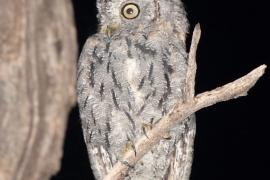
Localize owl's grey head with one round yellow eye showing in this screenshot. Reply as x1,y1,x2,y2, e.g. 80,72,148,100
97,0,188,37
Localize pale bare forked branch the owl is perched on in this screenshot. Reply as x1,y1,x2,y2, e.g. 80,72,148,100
104,25,266,180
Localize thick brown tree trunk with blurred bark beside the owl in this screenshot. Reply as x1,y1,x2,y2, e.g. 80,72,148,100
0,0,77,180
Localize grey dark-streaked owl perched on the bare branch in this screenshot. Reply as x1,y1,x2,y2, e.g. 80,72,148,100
77,0,195,180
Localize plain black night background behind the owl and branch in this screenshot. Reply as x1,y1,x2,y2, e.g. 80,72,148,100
52,0,270,180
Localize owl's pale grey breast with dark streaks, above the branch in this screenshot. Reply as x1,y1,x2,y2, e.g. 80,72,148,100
81,34,186,148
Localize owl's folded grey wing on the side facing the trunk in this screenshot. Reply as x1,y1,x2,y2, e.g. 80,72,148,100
77,36,112,179
